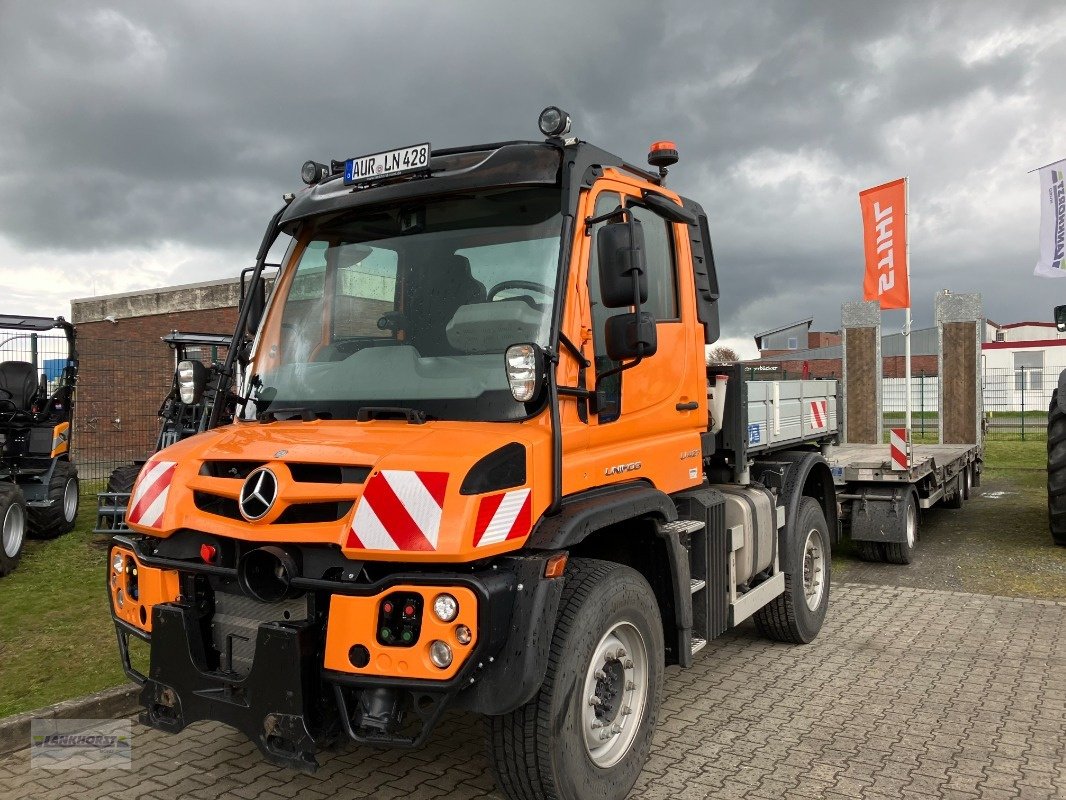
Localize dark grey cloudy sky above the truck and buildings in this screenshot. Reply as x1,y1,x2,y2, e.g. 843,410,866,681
0,0,1066,353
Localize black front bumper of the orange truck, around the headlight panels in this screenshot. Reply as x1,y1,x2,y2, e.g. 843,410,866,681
109,537,562,771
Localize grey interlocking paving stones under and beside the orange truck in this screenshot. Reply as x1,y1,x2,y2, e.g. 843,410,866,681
0,585,1066,800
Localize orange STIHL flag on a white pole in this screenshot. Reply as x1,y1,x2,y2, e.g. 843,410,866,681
859,178,910,308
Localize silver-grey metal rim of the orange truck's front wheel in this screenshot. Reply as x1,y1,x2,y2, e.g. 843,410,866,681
582,622,649,768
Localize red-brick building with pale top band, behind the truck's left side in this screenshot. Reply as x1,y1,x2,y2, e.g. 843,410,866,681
70,278,240,478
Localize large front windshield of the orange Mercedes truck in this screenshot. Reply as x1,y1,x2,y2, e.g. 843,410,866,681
245,188,561,420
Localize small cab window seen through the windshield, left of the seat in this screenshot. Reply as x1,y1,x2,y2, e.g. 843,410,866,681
333,244,398,339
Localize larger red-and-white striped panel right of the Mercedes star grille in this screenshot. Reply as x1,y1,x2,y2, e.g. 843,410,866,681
348,469,448,550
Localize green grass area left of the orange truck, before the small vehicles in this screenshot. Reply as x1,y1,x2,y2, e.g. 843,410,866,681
0,494,126,717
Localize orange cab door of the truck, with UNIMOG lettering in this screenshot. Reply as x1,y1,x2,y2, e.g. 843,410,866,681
567,178,707,499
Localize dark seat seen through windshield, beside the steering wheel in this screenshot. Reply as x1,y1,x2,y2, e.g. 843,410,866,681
405,253,488,356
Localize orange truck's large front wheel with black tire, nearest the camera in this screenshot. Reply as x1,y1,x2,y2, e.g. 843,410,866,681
487,558,665,800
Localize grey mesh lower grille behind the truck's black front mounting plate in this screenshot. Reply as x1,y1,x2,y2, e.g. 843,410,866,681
211,592,307,675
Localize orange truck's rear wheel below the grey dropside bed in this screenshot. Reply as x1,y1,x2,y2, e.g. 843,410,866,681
755,497,831,644
